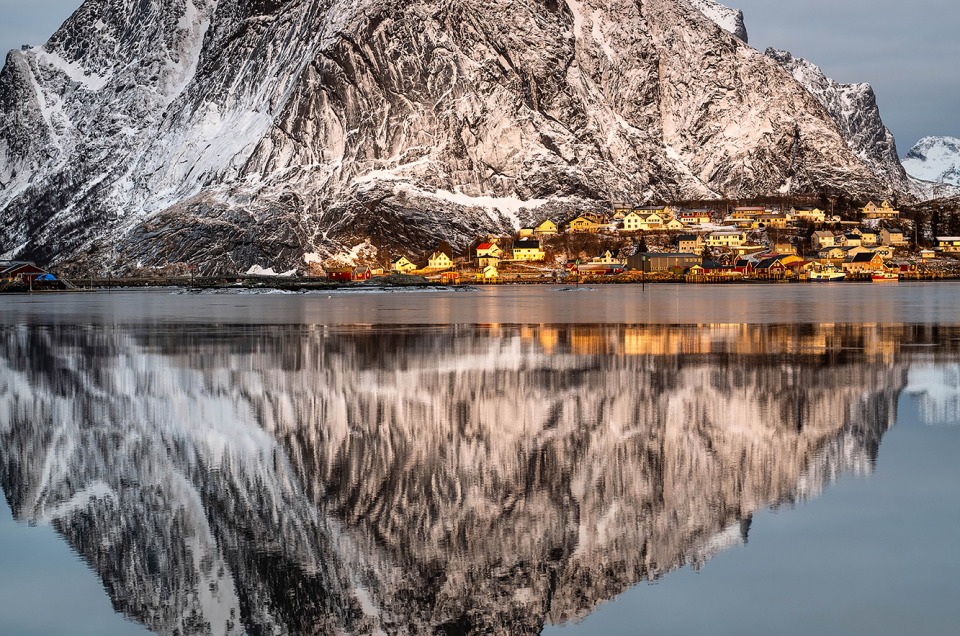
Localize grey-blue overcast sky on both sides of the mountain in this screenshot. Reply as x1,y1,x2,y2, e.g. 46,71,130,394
0,0,960,156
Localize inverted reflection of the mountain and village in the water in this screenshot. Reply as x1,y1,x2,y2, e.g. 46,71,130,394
0,325,960,634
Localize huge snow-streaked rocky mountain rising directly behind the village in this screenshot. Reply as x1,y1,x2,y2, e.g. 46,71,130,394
0,0,904,272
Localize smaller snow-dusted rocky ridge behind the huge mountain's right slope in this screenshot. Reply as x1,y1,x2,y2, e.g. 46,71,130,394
766,48,913,192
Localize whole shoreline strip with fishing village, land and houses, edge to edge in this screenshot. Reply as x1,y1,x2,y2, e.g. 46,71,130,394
0,201,960,292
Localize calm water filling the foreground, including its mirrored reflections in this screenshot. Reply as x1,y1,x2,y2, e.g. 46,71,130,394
0,283,960,635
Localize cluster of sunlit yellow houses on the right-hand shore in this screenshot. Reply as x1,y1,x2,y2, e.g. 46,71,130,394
348,196,948,281
